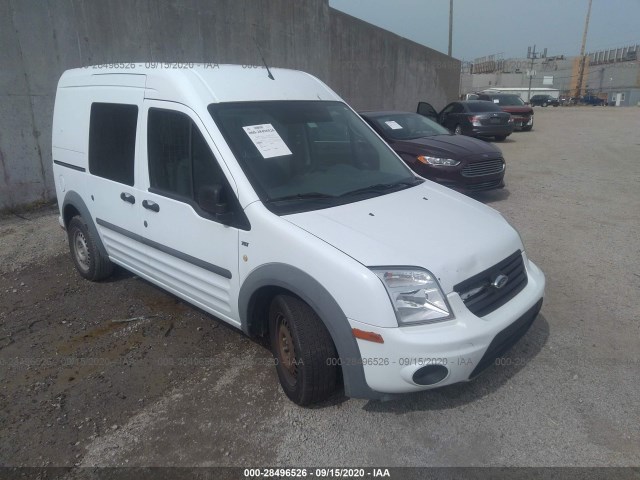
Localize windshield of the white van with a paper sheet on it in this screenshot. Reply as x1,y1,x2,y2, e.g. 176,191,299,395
209,101,422,214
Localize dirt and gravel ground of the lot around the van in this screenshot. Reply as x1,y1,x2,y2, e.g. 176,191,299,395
0,107,640,466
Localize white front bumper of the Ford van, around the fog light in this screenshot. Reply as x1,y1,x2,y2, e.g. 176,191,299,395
349,256,545,394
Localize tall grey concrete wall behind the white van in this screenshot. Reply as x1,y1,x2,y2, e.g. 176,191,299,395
0,0,460,209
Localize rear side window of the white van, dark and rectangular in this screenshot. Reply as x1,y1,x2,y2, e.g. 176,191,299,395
89,103,138,186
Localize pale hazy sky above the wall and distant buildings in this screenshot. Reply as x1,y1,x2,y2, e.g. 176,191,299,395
329,0,640,61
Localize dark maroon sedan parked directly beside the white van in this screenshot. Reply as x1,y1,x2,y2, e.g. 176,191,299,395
360,112,505,192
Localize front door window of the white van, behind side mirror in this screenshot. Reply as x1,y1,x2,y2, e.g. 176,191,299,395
147,108,225,202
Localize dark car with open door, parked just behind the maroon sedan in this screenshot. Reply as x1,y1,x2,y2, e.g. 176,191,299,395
418,100,513,142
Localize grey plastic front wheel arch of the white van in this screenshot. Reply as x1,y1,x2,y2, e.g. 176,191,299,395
238,263,385,399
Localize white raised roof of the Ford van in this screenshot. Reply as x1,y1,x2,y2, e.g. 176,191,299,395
58,62,342,104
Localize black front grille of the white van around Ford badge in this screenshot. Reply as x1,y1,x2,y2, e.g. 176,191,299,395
453,251,528,317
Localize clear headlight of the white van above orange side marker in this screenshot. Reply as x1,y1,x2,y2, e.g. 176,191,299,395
371,267,453,325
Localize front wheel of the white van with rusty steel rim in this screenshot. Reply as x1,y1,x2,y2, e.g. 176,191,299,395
269,295,338,406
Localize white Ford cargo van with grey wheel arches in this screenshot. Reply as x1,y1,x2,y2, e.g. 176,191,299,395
53,64,545,405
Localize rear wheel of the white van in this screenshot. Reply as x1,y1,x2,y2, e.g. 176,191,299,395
67,215,113,281
